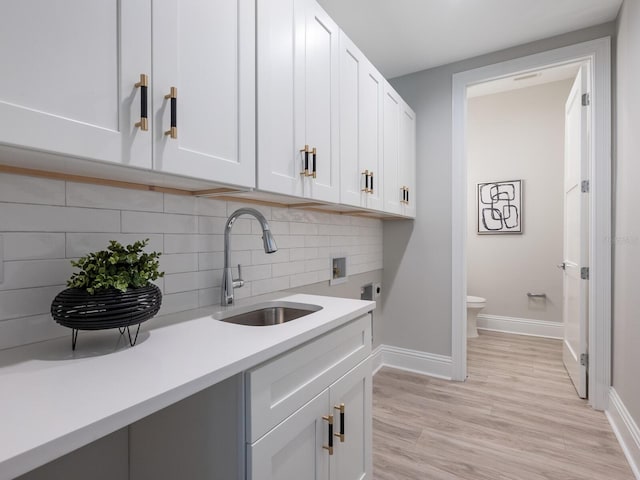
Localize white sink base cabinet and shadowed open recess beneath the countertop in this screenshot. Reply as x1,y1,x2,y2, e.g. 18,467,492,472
19,314,372,480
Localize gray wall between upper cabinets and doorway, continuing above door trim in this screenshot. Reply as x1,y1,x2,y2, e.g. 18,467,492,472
382,23,616,355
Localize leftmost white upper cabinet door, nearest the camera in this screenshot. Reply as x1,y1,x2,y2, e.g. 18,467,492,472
0,0,151,168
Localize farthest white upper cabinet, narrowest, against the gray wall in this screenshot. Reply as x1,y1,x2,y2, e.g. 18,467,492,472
384,82,416,218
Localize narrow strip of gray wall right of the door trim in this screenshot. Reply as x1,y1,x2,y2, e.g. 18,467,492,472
613,0,640,425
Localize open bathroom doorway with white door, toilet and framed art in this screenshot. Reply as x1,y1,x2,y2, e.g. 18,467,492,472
466,63,589,398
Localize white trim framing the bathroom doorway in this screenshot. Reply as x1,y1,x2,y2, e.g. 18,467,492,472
451,37,612,410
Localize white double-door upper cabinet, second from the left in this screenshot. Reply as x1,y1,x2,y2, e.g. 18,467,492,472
257,0,340,203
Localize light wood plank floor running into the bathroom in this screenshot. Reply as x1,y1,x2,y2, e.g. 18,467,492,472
373,331,634,480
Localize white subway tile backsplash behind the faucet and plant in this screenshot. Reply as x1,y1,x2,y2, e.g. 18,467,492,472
0,174,382,349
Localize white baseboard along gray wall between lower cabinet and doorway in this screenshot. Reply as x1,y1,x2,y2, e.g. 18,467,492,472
371,345,452,380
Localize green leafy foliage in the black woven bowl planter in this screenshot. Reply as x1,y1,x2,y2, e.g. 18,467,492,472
67,238,164,295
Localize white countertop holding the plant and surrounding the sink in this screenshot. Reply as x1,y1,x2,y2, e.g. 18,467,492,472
0,293,375,480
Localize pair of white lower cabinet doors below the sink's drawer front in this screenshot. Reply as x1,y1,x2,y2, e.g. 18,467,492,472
247,359,372,480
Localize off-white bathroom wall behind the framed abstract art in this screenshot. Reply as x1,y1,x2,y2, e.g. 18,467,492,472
467,80,572,322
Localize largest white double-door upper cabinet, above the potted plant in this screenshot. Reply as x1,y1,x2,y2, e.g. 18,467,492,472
0,0,255,187
